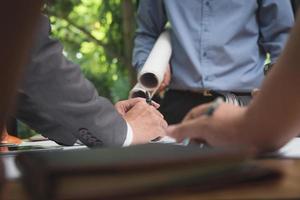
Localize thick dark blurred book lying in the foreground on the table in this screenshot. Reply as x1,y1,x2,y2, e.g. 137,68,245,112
16,144,280,200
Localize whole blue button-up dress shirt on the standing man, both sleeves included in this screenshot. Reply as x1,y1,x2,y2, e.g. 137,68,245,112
133,0,294,92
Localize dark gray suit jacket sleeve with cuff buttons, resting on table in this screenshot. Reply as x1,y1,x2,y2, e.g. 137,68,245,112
16,16,127,146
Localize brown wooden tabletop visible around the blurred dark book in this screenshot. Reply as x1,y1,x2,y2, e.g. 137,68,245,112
3,159,300,200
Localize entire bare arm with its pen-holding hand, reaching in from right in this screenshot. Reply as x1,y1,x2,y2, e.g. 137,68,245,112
169,13,300,152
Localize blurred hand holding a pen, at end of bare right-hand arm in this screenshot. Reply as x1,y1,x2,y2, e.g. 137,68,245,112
167,103,246,146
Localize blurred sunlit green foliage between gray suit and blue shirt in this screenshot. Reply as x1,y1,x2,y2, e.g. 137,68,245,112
18,0,138,138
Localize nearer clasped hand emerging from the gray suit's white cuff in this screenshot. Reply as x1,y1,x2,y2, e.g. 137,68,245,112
123,100,168,144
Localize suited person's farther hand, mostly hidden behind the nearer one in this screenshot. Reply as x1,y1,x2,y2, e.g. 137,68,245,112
115,97,159,116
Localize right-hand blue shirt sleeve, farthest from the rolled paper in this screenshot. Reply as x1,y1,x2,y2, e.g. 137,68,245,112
258,0,294,63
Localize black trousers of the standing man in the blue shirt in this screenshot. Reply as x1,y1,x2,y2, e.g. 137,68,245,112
159,90,251,124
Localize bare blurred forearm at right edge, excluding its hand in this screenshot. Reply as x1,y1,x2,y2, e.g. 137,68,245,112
240,16,300,151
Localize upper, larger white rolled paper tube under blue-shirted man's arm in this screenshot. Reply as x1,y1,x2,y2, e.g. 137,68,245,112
138,31,172,92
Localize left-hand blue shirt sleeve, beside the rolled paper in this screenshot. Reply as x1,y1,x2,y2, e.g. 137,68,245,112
132,0,167,70
